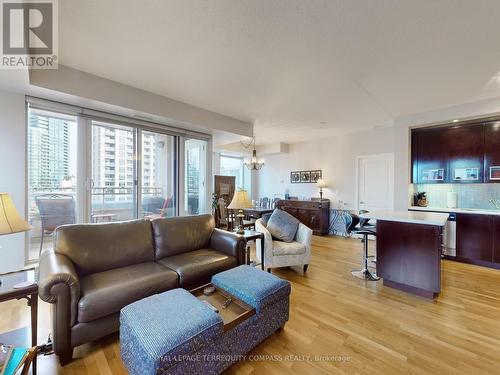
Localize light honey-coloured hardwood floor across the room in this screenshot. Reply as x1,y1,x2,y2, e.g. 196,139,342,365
0,237,500,375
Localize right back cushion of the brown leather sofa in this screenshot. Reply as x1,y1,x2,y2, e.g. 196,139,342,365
151,215,215,259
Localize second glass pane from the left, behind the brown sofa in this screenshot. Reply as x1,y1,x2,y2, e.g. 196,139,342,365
90,121,137,223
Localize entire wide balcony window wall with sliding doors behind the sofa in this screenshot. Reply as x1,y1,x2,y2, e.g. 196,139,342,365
27,102,208,260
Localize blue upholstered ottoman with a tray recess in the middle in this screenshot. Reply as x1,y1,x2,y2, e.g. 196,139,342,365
120,265,290,375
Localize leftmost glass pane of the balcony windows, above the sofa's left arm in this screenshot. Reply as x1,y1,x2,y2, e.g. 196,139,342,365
27,110,78,260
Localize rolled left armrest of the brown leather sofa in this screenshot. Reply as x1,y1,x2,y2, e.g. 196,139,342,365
38,250,80,326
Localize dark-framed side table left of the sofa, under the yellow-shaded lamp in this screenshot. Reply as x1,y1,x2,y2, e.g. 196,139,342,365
0,268,38,375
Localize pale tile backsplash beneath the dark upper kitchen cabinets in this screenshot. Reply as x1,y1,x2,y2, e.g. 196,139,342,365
413,184,500,209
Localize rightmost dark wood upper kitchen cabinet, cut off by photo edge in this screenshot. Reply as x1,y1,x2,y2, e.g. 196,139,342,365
484,121,500,182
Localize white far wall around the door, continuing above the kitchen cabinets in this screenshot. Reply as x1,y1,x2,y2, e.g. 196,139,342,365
256,99,500,210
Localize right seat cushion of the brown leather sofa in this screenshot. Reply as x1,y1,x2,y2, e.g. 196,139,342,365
158,249,237,287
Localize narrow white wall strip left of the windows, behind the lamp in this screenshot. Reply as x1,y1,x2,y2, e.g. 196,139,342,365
0,91,26,273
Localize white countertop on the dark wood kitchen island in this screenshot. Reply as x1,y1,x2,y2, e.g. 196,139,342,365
359,210,449,226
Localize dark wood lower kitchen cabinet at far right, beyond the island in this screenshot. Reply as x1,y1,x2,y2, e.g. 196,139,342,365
457,214,494,265
